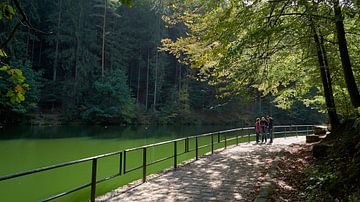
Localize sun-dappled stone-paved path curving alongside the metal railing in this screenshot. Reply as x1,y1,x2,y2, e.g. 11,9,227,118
96,136,305,202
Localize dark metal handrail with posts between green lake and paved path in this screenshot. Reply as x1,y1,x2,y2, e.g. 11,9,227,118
0,125,314,201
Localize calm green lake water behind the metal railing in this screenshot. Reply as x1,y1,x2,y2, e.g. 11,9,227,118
0,126,248,202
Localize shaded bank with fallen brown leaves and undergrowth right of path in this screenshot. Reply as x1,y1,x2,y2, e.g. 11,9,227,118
271,118,360,202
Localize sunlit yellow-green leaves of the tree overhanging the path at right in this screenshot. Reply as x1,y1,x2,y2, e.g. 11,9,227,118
162,0,360,116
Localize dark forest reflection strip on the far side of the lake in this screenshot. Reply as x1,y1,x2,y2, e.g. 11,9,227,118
0,126,236,140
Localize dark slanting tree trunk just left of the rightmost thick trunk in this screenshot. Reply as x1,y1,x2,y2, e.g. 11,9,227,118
311,24,339,129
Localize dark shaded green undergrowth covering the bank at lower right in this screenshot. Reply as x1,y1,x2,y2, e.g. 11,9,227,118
305,118,360,201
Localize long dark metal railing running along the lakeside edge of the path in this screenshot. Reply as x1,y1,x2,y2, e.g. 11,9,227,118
0,125,314,201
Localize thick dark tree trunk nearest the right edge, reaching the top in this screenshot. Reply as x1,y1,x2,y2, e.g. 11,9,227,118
334,0,360,108
